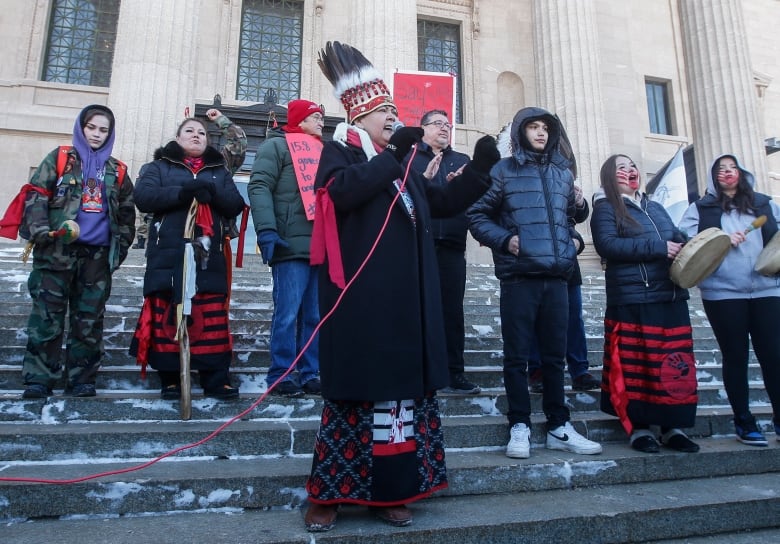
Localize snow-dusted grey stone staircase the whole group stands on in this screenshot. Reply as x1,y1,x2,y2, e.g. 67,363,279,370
0,244,780,544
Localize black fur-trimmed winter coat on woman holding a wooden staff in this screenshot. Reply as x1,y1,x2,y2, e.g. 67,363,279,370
133,141,244,303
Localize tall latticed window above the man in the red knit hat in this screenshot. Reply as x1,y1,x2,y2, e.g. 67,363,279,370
236,0,303,104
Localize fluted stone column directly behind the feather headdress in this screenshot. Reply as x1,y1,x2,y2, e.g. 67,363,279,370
344,0,417,83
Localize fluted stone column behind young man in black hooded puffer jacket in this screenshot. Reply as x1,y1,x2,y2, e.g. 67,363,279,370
528,0,610,200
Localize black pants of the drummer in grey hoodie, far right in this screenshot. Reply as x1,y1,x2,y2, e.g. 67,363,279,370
702,297,780,423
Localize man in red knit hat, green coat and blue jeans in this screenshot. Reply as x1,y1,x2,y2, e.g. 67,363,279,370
247,100,325,397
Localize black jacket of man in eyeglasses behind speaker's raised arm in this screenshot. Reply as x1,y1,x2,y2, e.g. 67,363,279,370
404,142,470,251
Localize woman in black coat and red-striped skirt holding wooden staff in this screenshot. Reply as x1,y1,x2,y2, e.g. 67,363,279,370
131,118,244,399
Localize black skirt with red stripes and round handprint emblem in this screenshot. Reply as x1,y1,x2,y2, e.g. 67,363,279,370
601,301,698,433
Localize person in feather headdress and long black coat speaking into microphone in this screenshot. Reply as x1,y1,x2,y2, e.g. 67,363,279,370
305,42,499,531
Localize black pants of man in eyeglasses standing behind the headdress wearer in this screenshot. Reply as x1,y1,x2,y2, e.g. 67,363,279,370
436,244,466,376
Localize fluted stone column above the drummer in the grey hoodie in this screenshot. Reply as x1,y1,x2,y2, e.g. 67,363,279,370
680,0,769,192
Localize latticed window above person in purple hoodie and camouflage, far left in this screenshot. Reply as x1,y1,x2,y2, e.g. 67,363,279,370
42,0,119,87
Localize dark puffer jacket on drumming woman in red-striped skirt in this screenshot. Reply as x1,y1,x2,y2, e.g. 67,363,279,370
590,195,688,306
